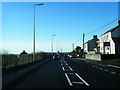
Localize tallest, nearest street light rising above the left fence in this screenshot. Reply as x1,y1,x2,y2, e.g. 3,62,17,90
33,3,43,61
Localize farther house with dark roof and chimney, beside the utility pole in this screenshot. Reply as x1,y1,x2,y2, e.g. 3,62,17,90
84,35,99,53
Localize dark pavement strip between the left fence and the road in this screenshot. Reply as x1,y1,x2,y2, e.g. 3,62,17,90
2,59,51,88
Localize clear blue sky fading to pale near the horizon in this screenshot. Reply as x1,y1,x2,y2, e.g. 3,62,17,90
2,2,118,54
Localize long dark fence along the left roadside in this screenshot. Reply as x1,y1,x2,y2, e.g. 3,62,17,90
2,54,50,70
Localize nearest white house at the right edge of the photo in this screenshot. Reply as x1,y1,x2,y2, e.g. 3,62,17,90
100,20,120,54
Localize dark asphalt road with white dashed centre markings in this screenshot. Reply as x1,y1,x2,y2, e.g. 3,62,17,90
7,57,120,88
